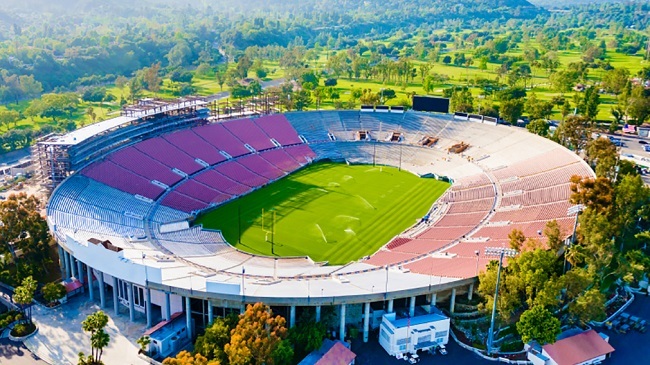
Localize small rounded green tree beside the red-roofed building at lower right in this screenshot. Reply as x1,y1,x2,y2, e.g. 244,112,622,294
517,305,562,345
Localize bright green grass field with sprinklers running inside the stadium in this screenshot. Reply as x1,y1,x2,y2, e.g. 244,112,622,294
196,162,449,264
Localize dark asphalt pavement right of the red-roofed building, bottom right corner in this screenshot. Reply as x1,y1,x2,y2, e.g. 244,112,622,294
598,294,650,365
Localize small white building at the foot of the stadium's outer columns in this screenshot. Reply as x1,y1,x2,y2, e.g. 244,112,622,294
379,309,449,357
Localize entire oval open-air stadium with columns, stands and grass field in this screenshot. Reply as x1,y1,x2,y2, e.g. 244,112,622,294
34,99,594,348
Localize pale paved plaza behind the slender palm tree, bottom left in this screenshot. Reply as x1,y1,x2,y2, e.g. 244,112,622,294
25,294,147,365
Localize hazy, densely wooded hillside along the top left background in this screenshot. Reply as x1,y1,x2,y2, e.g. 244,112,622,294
0,0,543,95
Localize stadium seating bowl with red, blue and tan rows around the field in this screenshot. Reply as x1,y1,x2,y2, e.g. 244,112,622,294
48,111,593,278
